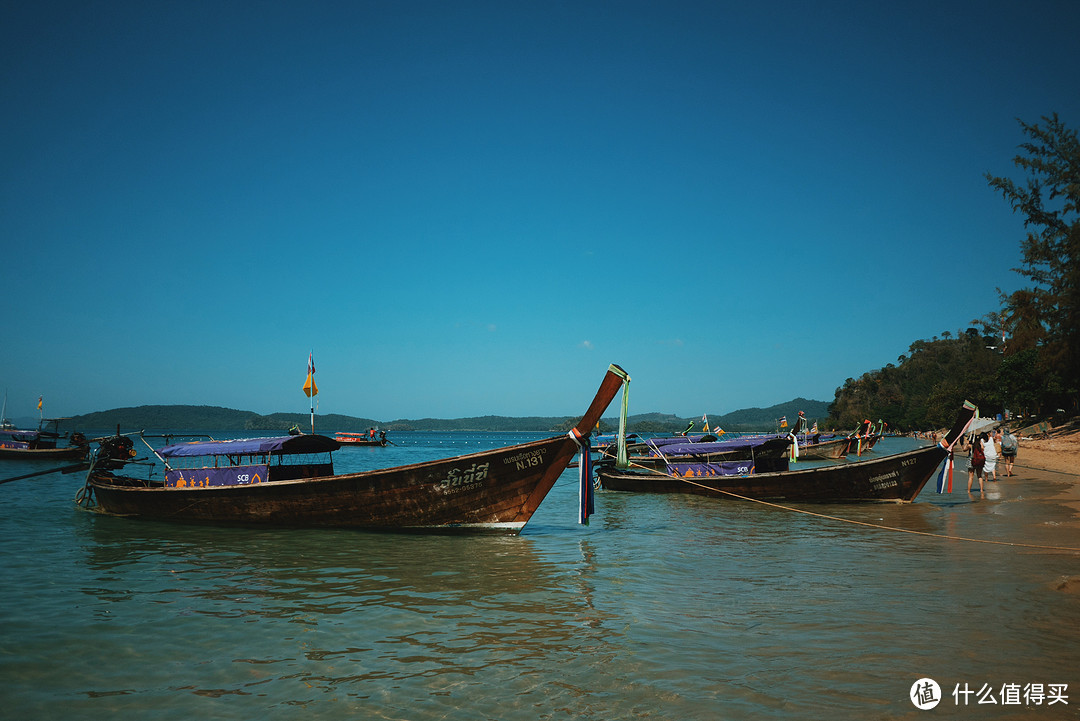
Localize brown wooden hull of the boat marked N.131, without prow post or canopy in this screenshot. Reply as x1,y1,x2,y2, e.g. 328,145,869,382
87,436,578,533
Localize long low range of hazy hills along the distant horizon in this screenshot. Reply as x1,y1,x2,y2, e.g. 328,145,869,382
56,398,828,433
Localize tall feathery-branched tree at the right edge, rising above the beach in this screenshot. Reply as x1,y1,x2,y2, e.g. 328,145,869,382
986,113,1080,409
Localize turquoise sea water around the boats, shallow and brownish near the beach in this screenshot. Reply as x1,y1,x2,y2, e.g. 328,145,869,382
0,433,1080,721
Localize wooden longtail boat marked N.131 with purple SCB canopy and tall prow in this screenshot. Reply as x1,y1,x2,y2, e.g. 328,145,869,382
76,365,629,533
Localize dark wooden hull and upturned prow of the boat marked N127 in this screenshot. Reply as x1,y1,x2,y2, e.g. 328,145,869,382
597,403,975,503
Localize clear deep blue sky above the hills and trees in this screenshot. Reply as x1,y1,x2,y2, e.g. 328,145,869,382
0,0,1080,420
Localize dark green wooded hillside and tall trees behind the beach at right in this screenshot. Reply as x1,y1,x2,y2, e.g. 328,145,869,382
829,114,1080,430
